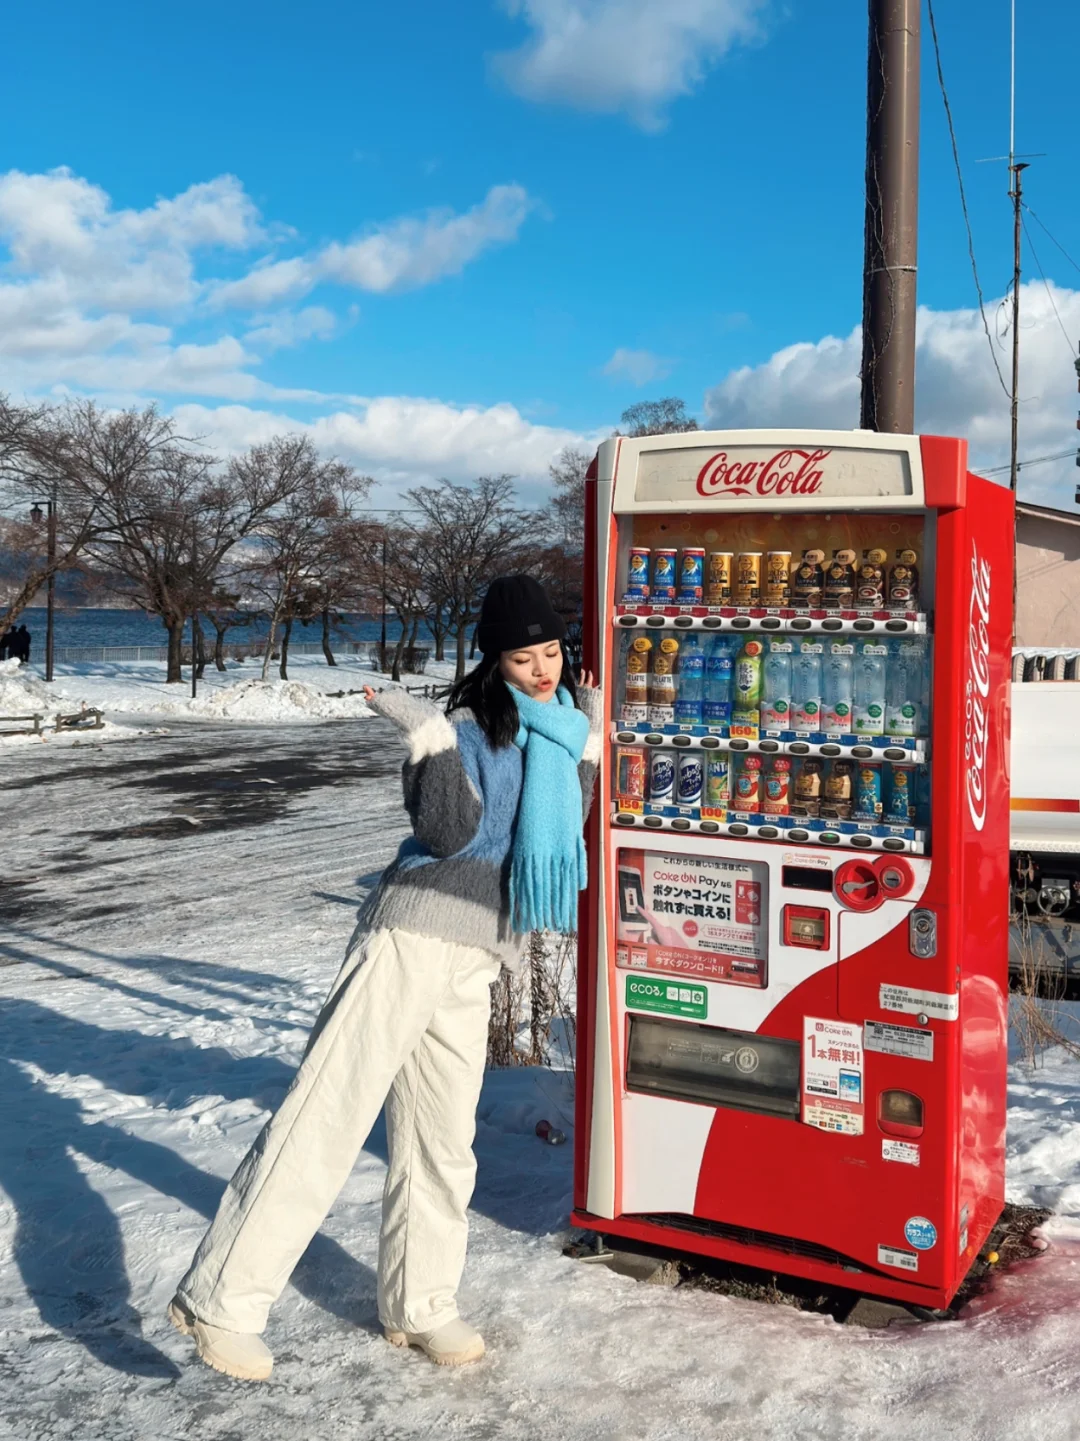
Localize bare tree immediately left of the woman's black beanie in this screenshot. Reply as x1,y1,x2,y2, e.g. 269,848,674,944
408,476,536,680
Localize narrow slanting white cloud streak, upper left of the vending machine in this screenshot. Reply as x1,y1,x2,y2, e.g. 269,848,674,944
212,184,532,308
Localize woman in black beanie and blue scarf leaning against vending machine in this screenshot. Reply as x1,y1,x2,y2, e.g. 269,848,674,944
169,575,601,1380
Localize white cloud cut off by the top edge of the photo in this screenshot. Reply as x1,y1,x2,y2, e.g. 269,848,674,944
495,0,769,130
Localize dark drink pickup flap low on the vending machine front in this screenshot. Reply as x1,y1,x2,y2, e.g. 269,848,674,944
626,1016,800,1120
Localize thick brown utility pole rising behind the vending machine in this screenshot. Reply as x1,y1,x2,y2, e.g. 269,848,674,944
859,0,920,434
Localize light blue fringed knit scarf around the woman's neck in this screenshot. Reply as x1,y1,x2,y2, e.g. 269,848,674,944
510,686,588,932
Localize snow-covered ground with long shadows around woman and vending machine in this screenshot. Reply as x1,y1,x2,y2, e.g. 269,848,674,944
0,694,1080,1441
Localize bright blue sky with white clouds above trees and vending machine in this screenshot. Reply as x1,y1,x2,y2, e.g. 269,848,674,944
0,0,1080,503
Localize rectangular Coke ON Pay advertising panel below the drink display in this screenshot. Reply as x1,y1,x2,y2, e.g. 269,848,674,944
616,849,769,987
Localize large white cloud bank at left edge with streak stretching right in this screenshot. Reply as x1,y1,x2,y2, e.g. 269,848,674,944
0,169,532,403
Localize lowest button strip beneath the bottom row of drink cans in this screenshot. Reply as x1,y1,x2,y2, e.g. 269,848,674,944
611,801,927,856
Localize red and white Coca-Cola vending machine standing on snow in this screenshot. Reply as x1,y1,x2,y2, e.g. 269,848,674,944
574,431,1014,1307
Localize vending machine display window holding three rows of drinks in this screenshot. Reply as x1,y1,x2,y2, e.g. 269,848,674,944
613,512,933,855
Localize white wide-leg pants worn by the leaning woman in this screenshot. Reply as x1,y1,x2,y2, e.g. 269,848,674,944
179,931,499,1333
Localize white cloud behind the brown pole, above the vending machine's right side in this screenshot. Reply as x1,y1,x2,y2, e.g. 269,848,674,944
705,281,1080,507
